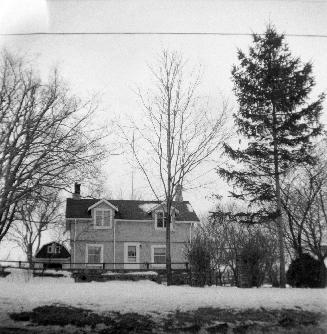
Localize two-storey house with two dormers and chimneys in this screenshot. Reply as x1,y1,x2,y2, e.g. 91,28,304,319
66,184,199,269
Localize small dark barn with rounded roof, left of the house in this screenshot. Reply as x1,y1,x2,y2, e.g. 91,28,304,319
33,242,70,269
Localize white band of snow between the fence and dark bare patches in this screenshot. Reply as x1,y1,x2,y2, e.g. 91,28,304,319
0,269,327,322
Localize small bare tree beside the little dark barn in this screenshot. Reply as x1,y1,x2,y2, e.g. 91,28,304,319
7,192,63,267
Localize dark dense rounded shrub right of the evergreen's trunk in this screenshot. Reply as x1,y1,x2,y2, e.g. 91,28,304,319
286,254,321,288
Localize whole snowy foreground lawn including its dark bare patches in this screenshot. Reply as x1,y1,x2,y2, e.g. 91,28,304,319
0,269,327,334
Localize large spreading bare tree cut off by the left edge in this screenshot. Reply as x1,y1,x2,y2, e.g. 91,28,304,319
0,50,105,241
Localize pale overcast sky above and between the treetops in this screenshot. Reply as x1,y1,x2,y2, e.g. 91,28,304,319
0,0,327,222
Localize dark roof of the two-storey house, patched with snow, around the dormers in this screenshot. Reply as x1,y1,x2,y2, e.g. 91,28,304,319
66,198,199,221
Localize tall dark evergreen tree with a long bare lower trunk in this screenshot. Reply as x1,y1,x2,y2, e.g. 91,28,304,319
219,26,324,287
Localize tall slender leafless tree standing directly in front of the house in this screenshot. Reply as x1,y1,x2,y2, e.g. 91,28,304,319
120,51,227,284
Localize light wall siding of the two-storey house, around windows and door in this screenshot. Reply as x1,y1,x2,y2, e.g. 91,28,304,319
69,217,191,269
